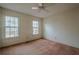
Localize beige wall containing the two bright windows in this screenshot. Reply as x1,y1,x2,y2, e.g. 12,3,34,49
2,9,42,46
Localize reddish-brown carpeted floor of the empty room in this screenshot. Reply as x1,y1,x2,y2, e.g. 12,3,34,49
0,39,79,55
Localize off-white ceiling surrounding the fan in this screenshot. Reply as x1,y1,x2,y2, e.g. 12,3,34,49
0,3,76,17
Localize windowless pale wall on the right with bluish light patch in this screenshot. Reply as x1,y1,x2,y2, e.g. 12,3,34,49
44,6,79,48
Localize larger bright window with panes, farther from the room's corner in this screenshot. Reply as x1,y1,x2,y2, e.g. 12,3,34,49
5,16,19,38
